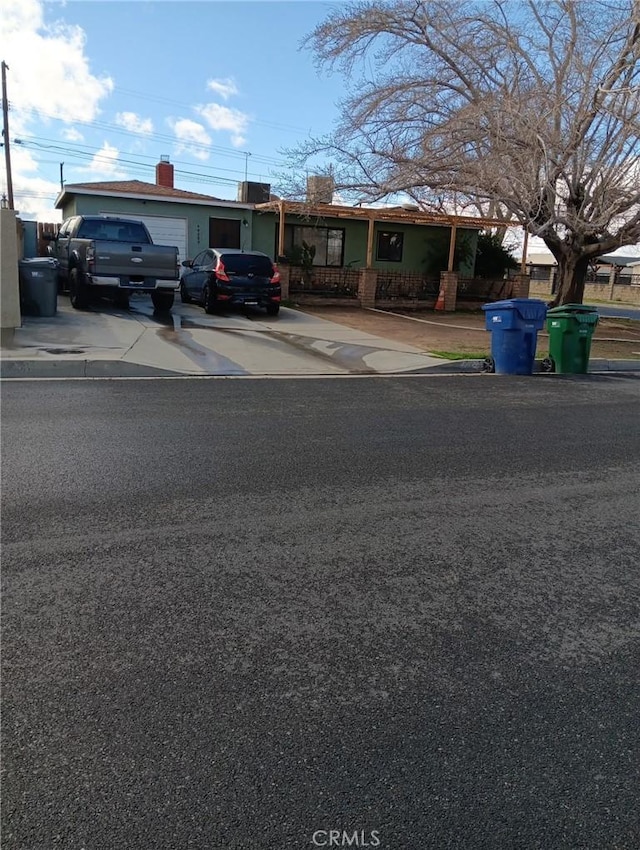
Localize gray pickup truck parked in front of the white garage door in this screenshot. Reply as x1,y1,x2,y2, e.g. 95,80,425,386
48,215,179,311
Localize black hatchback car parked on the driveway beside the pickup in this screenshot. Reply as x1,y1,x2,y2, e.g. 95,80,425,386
180,248,280,316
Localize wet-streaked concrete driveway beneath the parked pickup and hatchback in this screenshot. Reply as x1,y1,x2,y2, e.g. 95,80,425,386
2,296,450,377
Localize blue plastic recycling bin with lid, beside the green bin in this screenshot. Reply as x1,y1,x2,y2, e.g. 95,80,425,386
482,298,547,375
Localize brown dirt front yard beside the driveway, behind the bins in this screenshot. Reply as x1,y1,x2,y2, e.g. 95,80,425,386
297,306,640,360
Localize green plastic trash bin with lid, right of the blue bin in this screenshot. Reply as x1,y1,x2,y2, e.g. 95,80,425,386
547,304,598,375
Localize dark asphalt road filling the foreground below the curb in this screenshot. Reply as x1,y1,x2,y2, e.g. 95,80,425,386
2,375,640,850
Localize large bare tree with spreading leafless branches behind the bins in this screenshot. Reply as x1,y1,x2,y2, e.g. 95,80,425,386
290,0,640,304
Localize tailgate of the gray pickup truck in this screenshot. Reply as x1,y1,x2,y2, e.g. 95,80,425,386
95,241,178,281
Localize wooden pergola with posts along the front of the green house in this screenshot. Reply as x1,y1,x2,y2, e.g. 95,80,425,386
255,200,529,272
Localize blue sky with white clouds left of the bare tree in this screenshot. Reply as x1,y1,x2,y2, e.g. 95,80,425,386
0,0,344,220
